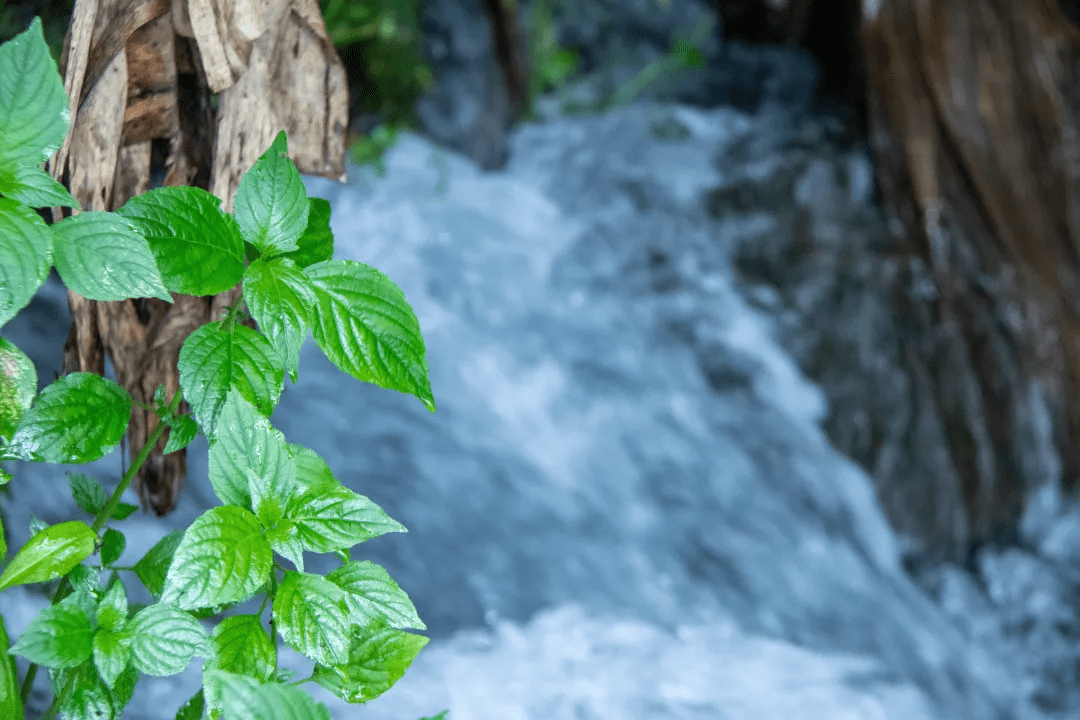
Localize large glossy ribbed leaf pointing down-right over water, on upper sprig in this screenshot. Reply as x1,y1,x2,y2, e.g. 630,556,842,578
303,260,435,411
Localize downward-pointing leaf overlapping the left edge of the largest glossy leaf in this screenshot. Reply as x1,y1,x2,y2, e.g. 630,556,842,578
244,258,315,382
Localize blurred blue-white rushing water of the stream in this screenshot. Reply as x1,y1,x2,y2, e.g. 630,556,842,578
0,101,1016,720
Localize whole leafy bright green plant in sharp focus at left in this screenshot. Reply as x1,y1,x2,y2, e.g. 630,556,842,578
0,19,435,720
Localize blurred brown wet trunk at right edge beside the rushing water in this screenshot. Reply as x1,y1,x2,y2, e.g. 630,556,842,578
863,0,1080,544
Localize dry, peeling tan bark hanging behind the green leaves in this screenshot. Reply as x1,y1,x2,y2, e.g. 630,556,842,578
50,0,348,514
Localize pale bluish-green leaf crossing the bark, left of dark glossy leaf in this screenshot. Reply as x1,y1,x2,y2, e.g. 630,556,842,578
53,213,173,302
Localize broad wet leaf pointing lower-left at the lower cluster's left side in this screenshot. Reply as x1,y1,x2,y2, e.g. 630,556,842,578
161,505,273,610
